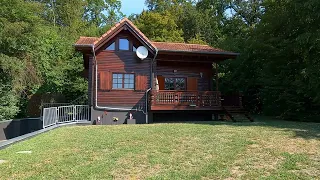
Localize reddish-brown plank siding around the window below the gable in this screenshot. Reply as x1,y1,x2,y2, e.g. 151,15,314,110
93,51,151,108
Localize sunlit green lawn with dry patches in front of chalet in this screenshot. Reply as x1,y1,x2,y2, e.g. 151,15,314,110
0,118,320,179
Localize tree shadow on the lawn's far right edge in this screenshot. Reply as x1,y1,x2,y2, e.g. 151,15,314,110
157,116,320,140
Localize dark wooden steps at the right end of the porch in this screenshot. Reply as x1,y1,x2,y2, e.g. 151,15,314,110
223,106,254,122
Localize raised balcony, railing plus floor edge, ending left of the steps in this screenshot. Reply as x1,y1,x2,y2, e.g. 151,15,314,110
150,90,222,110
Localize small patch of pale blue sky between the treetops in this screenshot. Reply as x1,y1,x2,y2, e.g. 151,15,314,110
121,0,146,17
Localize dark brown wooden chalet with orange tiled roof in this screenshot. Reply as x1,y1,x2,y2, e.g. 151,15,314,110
74,18,252,124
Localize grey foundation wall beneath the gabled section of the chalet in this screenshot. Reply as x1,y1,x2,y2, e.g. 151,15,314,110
91,108,146,125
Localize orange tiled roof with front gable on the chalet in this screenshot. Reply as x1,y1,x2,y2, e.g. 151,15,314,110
75,18,239,56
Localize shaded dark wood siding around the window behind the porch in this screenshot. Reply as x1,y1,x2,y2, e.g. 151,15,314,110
156,61,212,91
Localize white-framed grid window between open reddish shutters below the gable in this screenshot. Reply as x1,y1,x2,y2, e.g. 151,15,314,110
112,73,134,89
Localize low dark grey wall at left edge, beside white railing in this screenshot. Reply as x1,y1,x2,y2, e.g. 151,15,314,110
0,118,42,141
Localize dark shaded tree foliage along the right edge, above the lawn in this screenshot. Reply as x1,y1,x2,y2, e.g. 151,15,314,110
255,0,320,118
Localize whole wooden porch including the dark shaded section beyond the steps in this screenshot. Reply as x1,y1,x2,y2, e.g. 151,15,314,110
149,90,243,111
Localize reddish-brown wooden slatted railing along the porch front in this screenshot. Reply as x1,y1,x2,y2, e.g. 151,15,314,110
150,90,221,107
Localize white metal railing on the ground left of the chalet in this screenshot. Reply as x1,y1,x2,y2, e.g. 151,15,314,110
42,105,90,128
